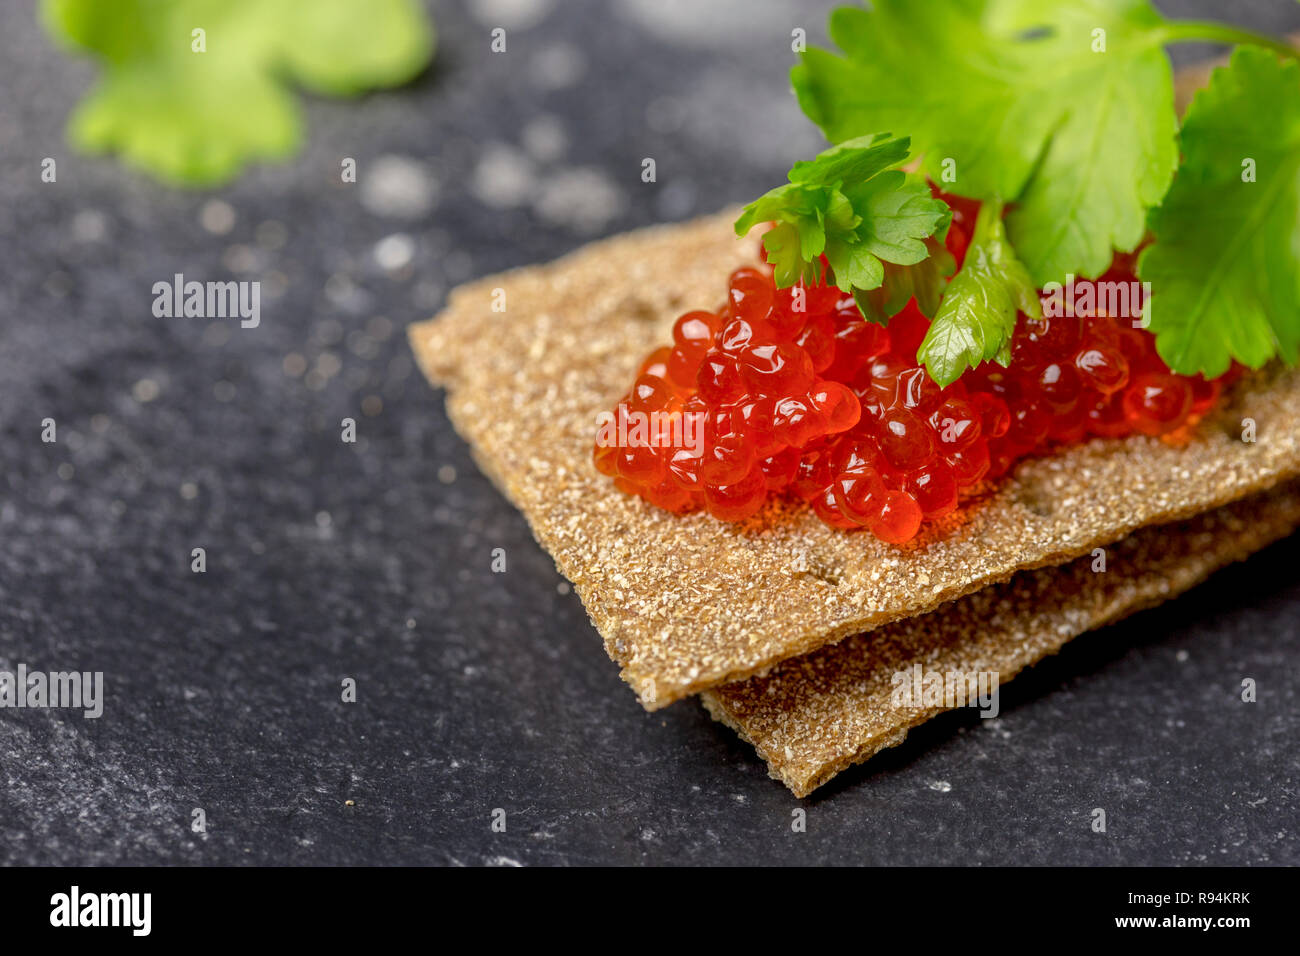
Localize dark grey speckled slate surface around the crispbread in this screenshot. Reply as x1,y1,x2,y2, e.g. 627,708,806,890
0,0,1300,865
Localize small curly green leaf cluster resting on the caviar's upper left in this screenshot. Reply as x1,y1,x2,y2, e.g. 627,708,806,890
736,134,952,293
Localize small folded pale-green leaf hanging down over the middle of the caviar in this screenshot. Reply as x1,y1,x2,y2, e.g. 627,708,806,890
917,202,1043,385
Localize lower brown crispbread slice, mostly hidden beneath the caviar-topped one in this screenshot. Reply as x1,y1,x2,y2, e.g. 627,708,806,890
702,483,1300,797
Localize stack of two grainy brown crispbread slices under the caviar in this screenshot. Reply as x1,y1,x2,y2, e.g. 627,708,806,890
411,70,1300,796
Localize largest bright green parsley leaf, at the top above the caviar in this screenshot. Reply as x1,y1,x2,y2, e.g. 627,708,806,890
792,0,1178,285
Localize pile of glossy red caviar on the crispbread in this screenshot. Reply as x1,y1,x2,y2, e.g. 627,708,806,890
594,196,1225,544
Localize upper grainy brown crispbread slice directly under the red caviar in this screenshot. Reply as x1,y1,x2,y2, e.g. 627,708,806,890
410,211,1300,709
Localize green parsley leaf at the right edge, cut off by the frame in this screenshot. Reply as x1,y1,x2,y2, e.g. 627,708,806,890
1139,48,1300,377
